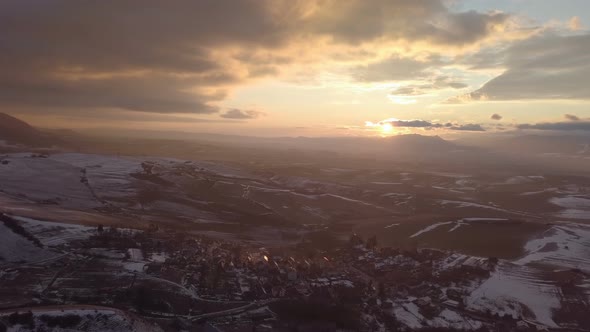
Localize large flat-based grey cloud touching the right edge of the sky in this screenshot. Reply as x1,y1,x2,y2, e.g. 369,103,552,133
447,34,590,103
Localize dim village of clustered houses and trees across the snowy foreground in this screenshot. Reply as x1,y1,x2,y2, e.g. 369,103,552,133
0,213,564,331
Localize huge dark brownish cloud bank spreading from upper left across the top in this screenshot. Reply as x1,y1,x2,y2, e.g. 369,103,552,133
0,0,511,114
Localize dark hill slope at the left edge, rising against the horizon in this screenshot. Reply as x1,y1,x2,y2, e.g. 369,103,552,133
0,113,62,147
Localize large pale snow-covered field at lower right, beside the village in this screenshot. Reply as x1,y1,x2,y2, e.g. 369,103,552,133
467,224,590,327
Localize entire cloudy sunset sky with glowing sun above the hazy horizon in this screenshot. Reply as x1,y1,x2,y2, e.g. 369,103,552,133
0,0,590,137
